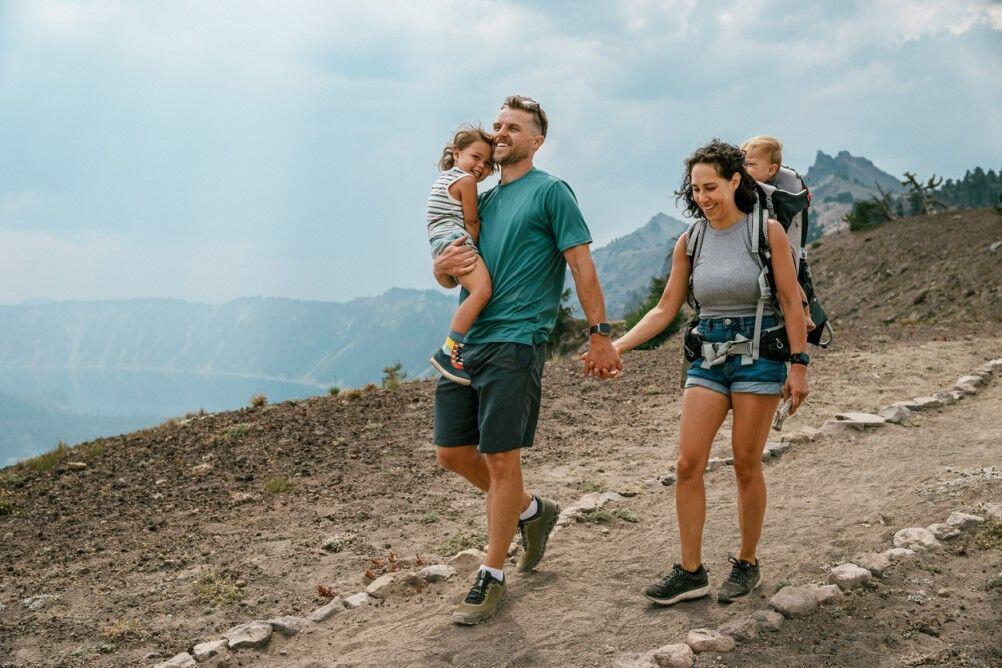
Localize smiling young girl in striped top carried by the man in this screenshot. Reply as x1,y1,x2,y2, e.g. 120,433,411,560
428,125,494,385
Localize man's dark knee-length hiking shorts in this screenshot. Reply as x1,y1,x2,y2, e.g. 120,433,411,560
435,343,546,454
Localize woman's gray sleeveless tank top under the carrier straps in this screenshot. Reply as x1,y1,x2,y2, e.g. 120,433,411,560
692,216,773,317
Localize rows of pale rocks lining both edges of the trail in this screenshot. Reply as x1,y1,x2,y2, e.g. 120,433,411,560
146,359,1002,668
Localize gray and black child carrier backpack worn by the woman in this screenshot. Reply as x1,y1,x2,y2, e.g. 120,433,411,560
682,183,834,383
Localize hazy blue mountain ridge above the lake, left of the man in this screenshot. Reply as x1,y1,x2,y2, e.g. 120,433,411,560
0,288,456,387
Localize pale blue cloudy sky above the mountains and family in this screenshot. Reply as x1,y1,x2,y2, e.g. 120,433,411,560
0,0,1002,303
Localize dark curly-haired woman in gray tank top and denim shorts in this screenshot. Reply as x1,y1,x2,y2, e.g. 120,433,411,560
614,139,809,605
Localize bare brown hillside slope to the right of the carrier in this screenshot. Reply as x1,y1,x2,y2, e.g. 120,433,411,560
810,209,1002,338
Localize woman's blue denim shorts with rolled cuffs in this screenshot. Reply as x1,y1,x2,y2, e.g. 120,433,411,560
685,315,787,396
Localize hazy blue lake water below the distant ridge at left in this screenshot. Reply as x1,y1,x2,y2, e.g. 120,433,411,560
0,369,327,466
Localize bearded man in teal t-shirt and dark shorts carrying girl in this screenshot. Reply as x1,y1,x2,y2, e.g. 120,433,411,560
435,95,622,624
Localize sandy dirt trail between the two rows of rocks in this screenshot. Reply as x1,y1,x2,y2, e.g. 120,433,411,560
238,366,1002,666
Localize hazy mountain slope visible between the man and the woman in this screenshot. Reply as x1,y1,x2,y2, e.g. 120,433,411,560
565,212,686,319
